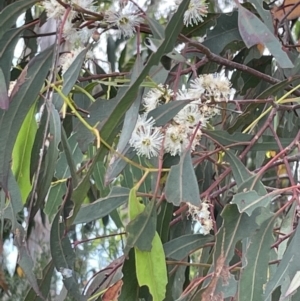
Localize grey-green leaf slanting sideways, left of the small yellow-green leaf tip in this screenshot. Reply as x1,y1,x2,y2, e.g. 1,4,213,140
74,186,129,224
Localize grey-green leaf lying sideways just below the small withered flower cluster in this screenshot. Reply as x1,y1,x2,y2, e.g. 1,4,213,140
164,234,214,260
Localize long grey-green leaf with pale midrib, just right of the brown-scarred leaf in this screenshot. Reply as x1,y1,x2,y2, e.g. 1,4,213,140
238,209,275,301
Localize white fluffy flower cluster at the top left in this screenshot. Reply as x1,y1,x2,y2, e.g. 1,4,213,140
42,0,141,73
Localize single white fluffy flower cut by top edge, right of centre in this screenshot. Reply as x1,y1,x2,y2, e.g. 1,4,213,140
176,0,208,26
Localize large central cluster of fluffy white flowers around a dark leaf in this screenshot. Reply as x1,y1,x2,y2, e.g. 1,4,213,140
129,74,231,158
